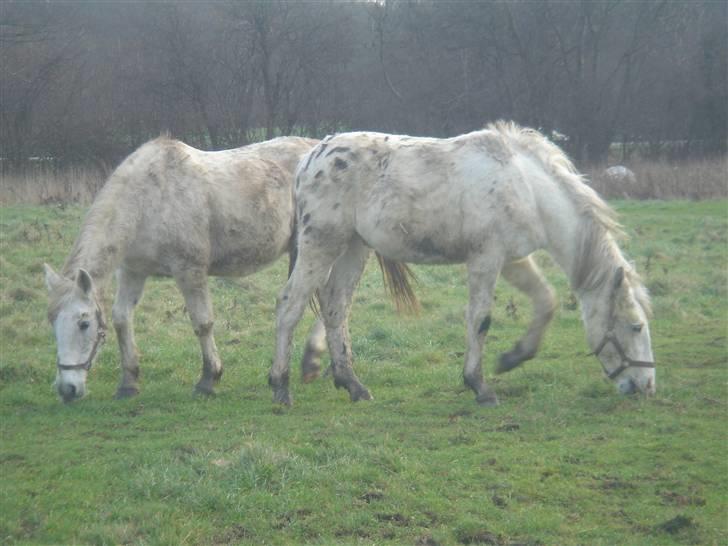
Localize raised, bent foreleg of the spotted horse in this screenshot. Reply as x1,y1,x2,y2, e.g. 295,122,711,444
495,256,556,373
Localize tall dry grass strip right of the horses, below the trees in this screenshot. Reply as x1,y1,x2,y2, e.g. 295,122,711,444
587,156,728,200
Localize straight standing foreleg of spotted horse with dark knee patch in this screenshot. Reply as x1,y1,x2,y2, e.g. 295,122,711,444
463,256,499,406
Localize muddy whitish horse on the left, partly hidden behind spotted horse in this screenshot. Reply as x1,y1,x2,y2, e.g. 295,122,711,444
45,137,325,401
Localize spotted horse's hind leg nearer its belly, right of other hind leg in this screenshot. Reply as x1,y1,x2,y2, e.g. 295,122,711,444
319,237,372,402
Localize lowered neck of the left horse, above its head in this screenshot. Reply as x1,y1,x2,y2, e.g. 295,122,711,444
63,190,136,288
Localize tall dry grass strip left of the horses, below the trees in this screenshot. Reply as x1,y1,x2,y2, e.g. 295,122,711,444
0,164,108,205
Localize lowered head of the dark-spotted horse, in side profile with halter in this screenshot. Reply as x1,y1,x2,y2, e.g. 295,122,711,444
585,267,656,394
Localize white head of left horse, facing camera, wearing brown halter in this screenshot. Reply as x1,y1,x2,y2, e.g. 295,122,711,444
45,264,106,402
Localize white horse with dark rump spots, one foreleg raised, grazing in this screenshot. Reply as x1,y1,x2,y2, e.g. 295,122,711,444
269,122,655,406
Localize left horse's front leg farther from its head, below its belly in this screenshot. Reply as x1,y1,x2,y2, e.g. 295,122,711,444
175,269,222,394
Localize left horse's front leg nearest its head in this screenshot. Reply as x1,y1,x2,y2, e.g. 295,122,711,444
111,268,146,398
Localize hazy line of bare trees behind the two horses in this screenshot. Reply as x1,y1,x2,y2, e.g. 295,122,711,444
0,0,728,166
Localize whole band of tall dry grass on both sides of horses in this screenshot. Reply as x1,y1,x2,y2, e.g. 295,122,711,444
0,156,728,205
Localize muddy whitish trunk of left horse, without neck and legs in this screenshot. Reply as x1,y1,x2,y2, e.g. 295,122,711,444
104,137,311,275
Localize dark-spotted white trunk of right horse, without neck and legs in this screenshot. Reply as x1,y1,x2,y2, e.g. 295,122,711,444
298,132,537,263
